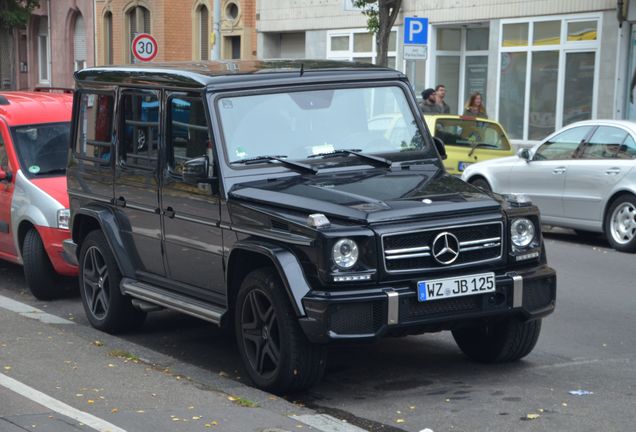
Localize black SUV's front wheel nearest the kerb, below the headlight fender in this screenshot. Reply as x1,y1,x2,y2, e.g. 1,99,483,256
234,268,326,394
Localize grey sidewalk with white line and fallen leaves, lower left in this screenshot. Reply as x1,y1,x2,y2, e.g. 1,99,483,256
0,296,361,432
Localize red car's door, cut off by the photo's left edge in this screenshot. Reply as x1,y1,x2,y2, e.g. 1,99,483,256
0,120,17,260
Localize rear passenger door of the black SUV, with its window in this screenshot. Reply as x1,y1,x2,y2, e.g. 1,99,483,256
114,90,165,277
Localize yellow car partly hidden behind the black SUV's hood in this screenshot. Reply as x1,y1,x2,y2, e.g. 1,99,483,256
424,114,514,174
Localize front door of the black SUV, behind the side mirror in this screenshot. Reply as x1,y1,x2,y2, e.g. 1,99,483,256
161,93,225,302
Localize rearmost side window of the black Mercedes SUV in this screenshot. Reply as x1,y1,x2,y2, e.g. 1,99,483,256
73,93,115,164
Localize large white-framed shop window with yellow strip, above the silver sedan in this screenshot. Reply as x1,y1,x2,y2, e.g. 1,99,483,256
497,16,600,141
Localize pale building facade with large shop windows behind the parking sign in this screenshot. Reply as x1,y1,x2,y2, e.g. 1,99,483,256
257,0,636,143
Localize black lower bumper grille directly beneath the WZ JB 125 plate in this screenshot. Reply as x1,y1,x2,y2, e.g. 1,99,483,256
400,296,482,322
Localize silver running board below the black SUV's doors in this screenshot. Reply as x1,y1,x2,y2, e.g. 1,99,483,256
121,278,225,325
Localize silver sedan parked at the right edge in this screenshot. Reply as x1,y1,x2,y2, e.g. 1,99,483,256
462,120,636,252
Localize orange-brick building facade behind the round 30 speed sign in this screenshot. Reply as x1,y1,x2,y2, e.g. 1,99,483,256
95,0,256,65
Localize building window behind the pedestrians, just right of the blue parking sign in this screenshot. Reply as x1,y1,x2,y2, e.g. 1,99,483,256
431,27,490,114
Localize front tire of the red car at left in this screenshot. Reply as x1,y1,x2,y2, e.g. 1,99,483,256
22,228,64,300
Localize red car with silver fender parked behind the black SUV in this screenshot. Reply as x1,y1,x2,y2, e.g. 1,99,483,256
0,92,77,300
